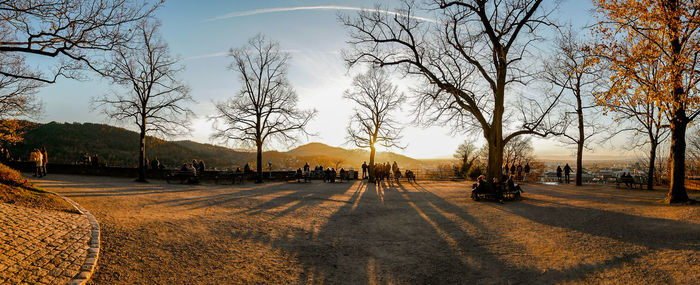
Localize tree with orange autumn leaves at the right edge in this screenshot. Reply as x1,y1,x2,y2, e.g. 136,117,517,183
591,0,700,203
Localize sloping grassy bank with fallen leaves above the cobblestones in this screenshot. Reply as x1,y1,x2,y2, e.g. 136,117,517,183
0,164,77,213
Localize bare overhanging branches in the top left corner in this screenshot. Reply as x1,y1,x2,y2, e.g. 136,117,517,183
0,0,157,83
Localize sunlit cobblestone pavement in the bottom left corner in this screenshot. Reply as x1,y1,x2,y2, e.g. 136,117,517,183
0,203,91,284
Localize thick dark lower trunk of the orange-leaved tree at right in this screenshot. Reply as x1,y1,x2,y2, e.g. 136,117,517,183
667,115,689,203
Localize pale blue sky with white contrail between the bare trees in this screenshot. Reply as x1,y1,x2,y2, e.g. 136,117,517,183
31,0,636,158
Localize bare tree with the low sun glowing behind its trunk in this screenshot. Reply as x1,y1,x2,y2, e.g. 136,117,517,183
343,68,406,182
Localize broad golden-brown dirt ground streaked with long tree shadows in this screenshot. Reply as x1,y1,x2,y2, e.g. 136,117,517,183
38,175,700,284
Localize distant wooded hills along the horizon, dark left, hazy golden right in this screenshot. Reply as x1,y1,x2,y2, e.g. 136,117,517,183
9,122,442,169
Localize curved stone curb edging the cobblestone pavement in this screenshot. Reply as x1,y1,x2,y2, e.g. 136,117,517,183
51,192,100,285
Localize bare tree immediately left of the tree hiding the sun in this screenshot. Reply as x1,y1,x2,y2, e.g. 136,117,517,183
211,35,316,183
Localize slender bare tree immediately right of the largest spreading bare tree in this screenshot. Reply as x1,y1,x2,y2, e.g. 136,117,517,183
543,27,604,186
